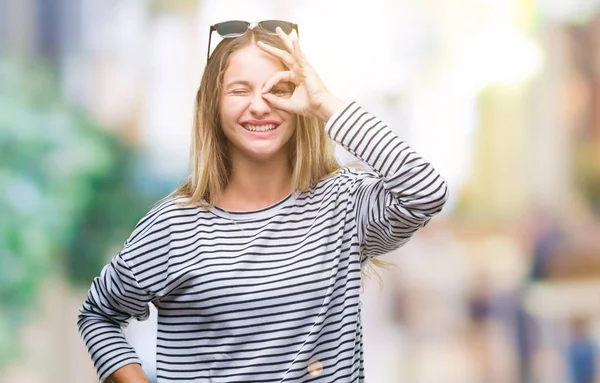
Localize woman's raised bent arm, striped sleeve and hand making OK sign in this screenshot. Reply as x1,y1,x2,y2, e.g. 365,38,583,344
257,28,448,261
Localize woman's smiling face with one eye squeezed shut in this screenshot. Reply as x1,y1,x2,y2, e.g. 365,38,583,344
219,44,296,166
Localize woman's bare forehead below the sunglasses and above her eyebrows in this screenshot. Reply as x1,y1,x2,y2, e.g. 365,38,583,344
223,44,286,85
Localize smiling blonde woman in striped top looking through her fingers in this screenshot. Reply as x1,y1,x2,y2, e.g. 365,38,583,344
78,21,447,382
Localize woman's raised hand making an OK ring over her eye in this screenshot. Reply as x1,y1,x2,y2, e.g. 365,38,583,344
257,27,343,120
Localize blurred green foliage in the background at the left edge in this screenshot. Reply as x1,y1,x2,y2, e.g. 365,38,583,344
0,59,156,368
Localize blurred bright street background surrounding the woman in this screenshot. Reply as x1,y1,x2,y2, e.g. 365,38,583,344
0,0,600,383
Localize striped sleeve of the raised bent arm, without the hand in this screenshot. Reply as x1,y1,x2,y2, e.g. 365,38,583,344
325,102,448,263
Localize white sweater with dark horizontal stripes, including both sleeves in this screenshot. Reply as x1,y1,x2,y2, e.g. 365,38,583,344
78,102,448,383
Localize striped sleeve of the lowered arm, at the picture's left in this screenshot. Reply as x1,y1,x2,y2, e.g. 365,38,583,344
77,202,170,382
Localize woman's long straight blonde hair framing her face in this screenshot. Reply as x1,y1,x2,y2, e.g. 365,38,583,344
171,28,341,206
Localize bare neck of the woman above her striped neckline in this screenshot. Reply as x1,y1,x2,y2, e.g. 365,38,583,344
217,151,292,211
